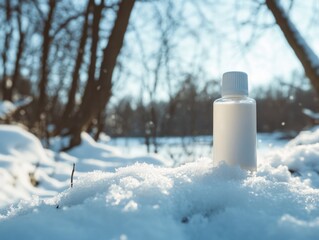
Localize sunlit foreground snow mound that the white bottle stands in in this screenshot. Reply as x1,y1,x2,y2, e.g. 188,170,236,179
0,159,319,239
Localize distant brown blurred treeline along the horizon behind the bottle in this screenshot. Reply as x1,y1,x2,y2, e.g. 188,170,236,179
105,81,319,137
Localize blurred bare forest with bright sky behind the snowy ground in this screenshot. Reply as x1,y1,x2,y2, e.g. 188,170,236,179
0,0,319,150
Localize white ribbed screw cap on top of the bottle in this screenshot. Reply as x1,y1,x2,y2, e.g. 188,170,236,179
221,71,248,96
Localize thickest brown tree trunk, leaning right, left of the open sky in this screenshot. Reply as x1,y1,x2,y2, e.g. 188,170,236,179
69,0,135,148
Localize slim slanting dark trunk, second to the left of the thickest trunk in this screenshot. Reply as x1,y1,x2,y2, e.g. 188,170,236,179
54,0,94,135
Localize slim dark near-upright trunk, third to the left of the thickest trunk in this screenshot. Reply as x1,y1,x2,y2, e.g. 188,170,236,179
35,0,56,122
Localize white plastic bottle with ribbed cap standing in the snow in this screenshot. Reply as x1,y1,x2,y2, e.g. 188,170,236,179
213,72,257,171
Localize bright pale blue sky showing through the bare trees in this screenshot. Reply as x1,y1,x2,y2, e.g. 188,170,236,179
3,0,319,101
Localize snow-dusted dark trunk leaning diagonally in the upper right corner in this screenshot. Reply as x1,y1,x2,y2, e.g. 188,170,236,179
266,0,319,94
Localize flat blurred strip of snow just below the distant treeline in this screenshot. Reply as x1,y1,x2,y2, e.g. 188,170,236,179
107,133,287,166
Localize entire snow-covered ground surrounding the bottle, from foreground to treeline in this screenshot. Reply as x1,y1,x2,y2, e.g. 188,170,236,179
0,125,319,239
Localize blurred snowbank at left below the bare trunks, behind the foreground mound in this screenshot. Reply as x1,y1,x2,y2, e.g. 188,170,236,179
0,125,174,208
